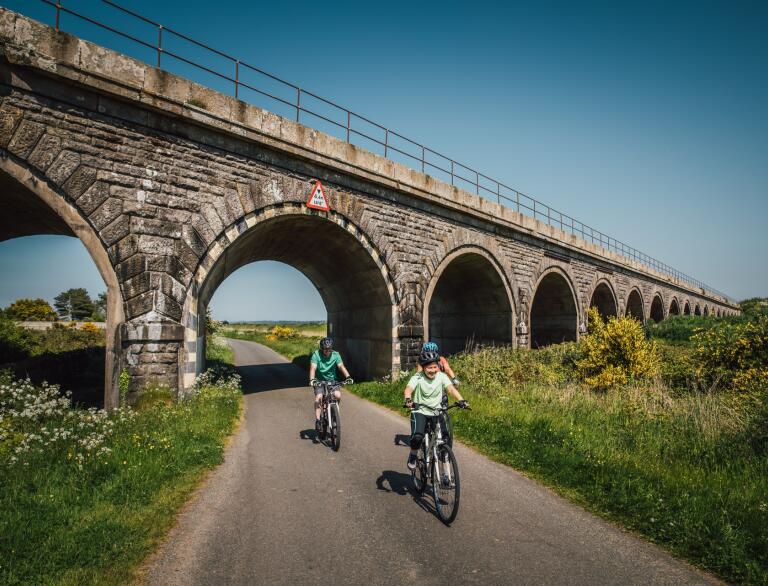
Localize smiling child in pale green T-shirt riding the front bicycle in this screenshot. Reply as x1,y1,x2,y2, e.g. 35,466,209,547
404,350,469,470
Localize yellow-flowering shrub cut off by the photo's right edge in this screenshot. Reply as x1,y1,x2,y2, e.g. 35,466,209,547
691,315,768,391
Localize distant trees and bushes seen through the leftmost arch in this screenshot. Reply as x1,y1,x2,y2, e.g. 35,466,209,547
0,287,107,321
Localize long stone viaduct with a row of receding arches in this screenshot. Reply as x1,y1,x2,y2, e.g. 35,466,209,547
0,9,738,407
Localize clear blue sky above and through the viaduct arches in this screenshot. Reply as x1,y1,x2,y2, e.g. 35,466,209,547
0,0,768,319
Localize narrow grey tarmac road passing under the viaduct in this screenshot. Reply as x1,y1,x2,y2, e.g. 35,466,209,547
146,340,717,586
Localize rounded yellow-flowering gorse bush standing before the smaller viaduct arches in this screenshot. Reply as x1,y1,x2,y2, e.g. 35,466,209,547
576,307,659,389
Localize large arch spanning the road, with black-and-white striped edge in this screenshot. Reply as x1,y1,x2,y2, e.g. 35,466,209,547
180,203,399,389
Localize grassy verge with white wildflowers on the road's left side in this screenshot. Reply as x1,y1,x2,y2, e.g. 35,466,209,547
0,338,242,585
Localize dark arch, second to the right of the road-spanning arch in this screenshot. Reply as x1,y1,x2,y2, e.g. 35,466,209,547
528,266,579,348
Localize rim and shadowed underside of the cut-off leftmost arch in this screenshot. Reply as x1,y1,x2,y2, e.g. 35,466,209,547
0,157,125,409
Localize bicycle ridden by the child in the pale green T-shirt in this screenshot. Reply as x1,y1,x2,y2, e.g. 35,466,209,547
411,403,469,525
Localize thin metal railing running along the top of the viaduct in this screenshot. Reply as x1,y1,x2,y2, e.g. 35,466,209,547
31,0,735,303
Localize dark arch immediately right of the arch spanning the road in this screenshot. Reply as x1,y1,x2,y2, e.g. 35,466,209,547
424,246,515,354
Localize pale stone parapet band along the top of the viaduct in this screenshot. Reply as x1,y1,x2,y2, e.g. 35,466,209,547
0,7,738,309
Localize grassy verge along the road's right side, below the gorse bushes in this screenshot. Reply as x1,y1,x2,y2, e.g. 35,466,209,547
249,322,768,584
